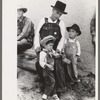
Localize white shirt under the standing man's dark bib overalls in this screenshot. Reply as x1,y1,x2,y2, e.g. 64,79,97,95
34,17,65,51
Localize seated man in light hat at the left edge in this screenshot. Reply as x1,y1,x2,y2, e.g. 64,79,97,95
17,7,34,54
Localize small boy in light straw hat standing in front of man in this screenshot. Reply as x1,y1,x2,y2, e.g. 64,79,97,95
39,35,59,100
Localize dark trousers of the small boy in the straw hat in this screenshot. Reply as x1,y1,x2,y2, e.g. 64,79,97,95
43,67,56,96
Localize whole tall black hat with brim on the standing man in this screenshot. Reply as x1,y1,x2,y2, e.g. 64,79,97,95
51,1,67,14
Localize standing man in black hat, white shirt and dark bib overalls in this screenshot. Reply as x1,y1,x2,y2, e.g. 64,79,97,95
34,1,67,94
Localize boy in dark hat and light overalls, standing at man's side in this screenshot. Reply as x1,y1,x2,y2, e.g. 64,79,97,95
63,24,81,82
